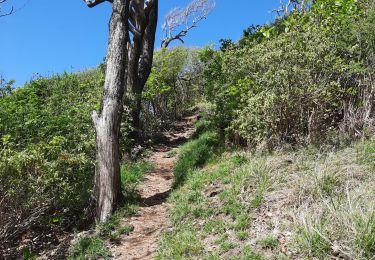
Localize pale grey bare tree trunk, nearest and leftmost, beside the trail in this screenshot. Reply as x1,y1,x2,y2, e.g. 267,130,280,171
92,0,129,222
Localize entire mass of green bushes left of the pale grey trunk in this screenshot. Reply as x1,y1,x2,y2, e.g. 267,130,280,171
0,69,103,256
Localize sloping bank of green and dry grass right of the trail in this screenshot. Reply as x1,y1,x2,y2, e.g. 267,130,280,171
158,135,375,259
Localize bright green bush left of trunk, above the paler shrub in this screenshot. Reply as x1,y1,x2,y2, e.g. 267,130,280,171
0,70,103,146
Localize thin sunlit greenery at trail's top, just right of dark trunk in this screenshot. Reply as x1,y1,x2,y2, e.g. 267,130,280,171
143,48,206,133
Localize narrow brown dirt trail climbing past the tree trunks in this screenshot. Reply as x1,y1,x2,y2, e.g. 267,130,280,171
111,116,197,260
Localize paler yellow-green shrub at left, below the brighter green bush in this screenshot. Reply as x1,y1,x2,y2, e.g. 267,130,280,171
0,137,94,230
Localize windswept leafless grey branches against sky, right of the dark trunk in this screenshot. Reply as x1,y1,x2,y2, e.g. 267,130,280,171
162,0,216,48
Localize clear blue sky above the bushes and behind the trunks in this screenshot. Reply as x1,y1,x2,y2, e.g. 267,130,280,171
0,0,279,85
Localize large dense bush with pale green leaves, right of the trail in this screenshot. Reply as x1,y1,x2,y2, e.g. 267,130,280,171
201,0,375,148
